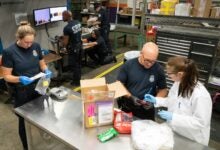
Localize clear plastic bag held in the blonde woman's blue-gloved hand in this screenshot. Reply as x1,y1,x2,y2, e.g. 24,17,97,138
35,77,50,95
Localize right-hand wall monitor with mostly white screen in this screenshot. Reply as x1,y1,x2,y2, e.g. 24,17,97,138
50,6,67,22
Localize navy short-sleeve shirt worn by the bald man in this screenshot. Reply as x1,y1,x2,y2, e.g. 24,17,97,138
117,58,167,99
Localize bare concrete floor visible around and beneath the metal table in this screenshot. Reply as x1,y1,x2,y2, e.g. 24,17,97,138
0,41,220,150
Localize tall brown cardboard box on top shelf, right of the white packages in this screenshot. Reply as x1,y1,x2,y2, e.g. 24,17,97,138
193,0,212,18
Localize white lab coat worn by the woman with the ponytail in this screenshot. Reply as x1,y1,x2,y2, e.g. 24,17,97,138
155,82,212,145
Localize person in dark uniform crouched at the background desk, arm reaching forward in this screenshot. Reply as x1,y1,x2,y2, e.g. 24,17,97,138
82,30,117,65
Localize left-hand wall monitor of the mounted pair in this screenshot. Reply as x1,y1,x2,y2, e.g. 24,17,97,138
33,8,50,26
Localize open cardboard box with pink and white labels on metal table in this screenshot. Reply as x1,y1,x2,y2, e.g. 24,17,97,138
80,78,128,128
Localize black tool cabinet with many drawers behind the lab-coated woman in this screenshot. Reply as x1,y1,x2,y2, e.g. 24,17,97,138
156,27,220,91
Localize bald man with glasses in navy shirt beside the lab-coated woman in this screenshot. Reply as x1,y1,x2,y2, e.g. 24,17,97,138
117,42,167,120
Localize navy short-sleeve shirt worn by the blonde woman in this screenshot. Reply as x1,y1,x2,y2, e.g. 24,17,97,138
2,43,43,77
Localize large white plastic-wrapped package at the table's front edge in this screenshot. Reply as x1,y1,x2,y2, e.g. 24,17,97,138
131,120,174,150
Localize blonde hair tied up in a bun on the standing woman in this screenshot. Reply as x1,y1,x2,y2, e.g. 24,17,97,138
15,21,36,39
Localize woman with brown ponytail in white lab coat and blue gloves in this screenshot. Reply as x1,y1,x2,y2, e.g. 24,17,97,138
145,56,212,145
